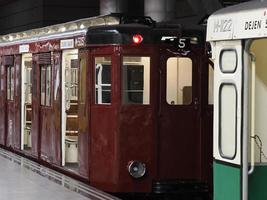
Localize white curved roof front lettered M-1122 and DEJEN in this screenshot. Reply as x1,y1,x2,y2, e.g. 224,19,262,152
207,0,267,41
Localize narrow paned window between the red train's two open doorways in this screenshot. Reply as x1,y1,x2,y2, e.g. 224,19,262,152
41,65,51,106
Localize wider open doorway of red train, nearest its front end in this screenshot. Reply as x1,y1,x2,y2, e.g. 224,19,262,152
61,49,79,170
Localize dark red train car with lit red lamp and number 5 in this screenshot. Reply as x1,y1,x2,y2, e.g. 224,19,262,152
0,15,213,198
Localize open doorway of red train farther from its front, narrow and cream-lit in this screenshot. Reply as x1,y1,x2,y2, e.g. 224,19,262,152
21,53,32,151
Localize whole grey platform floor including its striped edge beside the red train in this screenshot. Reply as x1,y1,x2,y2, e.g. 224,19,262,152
0,149,117,200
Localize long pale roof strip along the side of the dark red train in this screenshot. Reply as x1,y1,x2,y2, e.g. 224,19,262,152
0,14,121,46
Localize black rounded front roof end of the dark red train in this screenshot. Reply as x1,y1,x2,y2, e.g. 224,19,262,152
86,23,205,45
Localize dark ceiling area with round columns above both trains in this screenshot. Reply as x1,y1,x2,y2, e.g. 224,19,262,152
0,0,251,35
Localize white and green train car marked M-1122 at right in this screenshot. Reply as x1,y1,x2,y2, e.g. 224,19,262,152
207,0,267,200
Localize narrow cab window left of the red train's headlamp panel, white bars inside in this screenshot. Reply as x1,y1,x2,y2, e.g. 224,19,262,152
95,57,111,104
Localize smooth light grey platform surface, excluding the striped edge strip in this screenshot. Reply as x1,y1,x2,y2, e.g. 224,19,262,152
0,150,116,200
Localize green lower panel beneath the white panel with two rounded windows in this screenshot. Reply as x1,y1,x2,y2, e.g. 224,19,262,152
213,162,241,200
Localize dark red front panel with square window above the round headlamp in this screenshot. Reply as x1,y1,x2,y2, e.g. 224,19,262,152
117,46,158,192
